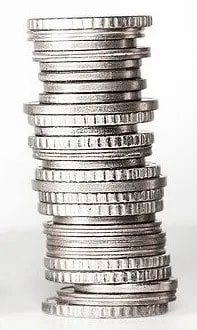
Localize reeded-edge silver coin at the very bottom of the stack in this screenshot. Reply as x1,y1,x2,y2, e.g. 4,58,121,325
42,298,168,319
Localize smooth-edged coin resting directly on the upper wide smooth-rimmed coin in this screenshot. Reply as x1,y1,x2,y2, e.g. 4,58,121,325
39,91,141,104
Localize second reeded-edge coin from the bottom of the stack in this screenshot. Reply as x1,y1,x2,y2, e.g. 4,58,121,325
45,266,171,284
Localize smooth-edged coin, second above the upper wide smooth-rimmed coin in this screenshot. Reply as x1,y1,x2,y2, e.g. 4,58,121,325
44,79,146,94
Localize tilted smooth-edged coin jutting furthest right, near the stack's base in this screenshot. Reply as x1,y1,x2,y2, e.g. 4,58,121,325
74,277,178,294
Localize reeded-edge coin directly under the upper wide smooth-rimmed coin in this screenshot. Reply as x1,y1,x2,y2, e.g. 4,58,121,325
28,111,154,127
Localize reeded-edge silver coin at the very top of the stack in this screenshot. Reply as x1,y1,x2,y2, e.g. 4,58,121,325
27,16,152,31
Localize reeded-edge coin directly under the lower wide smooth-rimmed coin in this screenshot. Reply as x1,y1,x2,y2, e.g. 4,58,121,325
39,188,164,204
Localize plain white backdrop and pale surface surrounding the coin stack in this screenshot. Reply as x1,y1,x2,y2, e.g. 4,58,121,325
0,0,197,330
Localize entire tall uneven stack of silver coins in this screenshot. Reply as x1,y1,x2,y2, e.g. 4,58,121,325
24,16,177,318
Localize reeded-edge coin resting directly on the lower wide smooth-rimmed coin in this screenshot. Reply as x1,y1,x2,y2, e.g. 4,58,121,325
35,163,161,182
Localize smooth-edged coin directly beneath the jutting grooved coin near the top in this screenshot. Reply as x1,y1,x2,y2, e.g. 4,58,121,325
40,59,142,72
